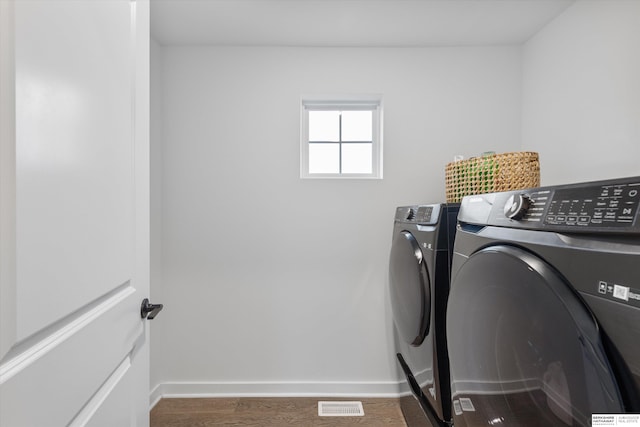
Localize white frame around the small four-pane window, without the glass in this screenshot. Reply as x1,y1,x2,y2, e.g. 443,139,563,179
300,95,382,179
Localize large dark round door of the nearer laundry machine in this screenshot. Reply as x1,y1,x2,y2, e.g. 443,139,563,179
447,246,623,427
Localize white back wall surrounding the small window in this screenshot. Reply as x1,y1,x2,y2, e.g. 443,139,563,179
152,46,521,398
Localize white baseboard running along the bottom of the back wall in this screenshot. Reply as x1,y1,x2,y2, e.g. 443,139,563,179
149,381,409,408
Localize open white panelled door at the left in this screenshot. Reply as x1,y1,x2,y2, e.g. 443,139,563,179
0,0,149,427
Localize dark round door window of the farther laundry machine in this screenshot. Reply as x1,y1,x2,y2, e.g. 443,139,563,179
389,231,431,346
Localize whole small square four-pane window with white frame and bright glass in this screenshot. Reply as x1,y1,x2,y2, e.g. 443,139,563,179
300,96,382,178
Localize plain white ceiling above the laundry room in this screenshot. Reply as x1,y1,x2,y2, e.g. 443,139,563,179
151,0,576,47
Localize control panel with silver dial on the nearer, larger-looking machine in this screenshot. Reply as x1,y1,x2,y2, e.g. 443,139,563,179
458,177,640,234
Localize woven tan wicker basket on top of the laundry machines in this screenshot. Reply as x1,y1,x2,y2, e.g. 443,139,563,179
445,151,540,203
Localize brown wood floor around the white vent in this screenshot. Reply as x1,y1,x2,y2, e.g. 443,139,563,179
151,398,406,427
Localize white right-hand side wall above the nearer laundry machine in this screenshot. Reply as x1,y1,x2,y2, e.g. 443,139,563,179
522,0,640,185
